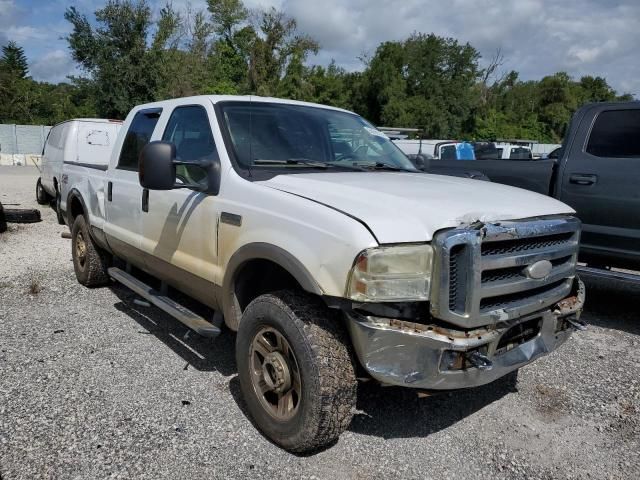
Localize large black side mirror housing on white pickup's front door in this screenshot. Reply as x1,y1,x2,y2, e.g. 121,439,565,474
138,142,176,190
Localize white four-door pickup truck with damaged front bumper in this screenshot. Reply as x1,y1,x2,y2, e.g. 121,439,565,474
61,96,584,452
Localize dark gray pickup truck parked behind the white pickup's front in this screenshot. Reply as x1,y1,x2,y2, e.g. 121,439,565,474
424,101,640,270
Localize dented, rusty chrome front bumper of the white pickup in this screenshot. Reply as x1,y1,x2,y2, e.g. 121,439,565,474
345,277,584,390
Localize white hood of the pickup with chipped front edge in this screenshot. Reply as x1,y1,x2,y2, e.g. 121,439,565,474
258,172,575,243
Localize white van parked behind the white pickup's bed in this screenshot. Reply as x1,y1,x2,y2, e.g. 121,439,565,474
36,118,122,223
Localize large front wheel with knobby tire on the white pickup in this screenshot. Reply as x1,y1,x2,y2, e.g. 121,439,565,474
236,290,357,452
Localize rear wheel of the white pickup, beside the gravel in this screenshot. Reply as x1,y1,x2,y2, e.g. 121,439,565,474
71,215,110,287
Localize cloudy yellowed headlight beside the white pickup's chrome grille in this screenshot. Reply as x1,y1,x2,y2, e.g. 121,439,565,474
347,245,433,302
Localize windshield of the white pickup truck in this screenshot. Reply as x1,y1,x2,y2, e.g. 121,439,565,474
220,102,418,173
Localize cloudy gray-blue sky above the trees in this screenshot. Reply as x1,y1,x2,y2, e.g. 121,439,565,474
5,0,640,97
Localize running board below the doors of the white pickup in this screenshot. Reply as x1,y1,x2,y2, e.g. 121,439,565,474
109,267,220,338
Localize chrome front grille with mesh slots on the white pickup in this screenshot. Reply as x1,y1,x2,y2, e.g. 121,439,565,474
431,217,580,327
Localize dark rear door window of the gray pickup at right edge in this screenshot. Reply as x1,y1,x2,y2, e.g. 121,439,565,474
587,109,640,158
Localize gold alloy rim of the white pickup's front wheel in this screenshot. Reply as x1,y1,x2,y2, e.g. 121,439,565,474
249,327,302,421
